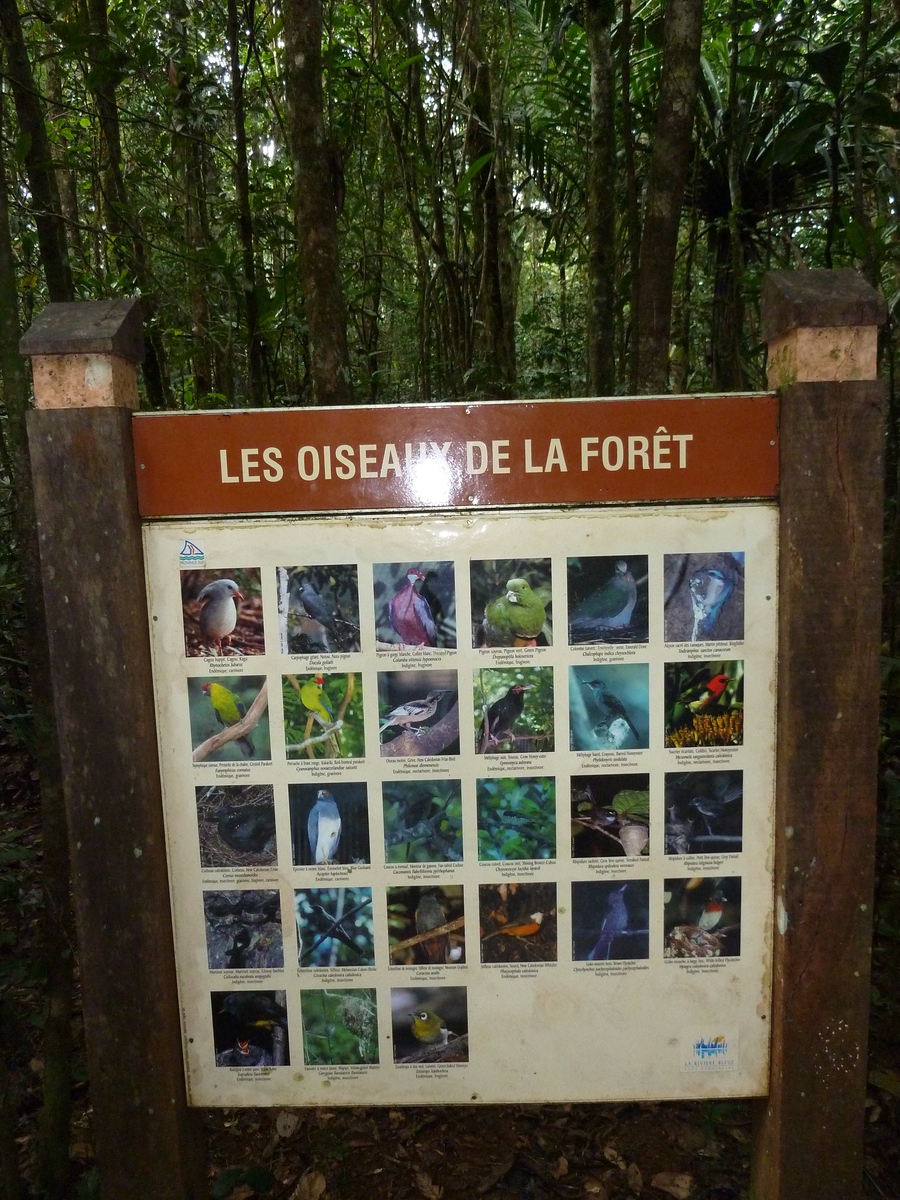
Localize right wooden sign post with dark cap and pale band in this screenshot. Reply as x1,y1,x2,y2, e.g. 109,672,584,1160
752,270,886,1200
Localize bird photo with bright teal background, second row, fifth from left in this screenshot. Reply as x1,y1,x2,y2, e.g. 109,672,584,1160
569,662,650,751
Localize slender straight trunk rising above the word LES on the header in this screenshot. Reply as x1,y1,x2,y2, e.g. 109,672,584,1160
228,0,269,408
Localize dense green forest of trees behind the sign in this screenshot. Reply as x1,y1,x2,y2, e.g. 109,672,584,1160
0,0,900,1200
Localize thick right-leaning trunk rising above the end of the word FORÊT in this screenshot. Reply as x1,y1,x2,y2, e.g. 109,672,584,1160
635,0,703,392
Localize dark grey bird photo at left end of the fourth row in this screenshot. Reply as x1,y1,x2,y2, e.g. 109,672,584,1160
203,889,284,971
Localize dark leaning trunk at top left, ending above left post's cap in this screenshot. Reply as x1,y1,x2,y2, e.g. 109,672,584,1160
0,0,74,301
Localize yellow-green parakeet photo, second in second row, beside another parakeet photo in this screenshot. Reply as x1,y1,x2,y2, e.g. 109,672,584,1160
281,671,366,760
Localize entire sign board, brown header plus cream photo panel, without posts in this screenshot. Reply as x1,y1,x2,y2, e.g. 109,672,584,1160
134,395,778,1105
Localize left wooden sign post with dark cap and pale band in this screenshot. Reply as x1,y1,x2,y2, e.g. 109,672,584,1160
20,300,206,1200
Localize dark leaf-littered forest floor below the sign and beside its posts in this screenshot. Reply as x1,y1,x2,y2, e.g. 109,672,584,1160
0,729,900,1200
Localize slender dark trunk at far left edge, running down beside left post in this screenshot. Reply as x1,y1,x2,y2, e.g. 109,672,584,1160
0,72,73,1200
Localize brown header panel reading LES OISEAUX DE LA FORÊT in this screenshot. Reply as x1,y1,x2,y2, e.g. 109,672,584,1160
134,395,778,517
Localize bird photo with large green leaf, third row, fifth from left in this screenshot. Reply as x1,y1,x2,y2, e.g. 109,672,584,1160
571,774,650,858
